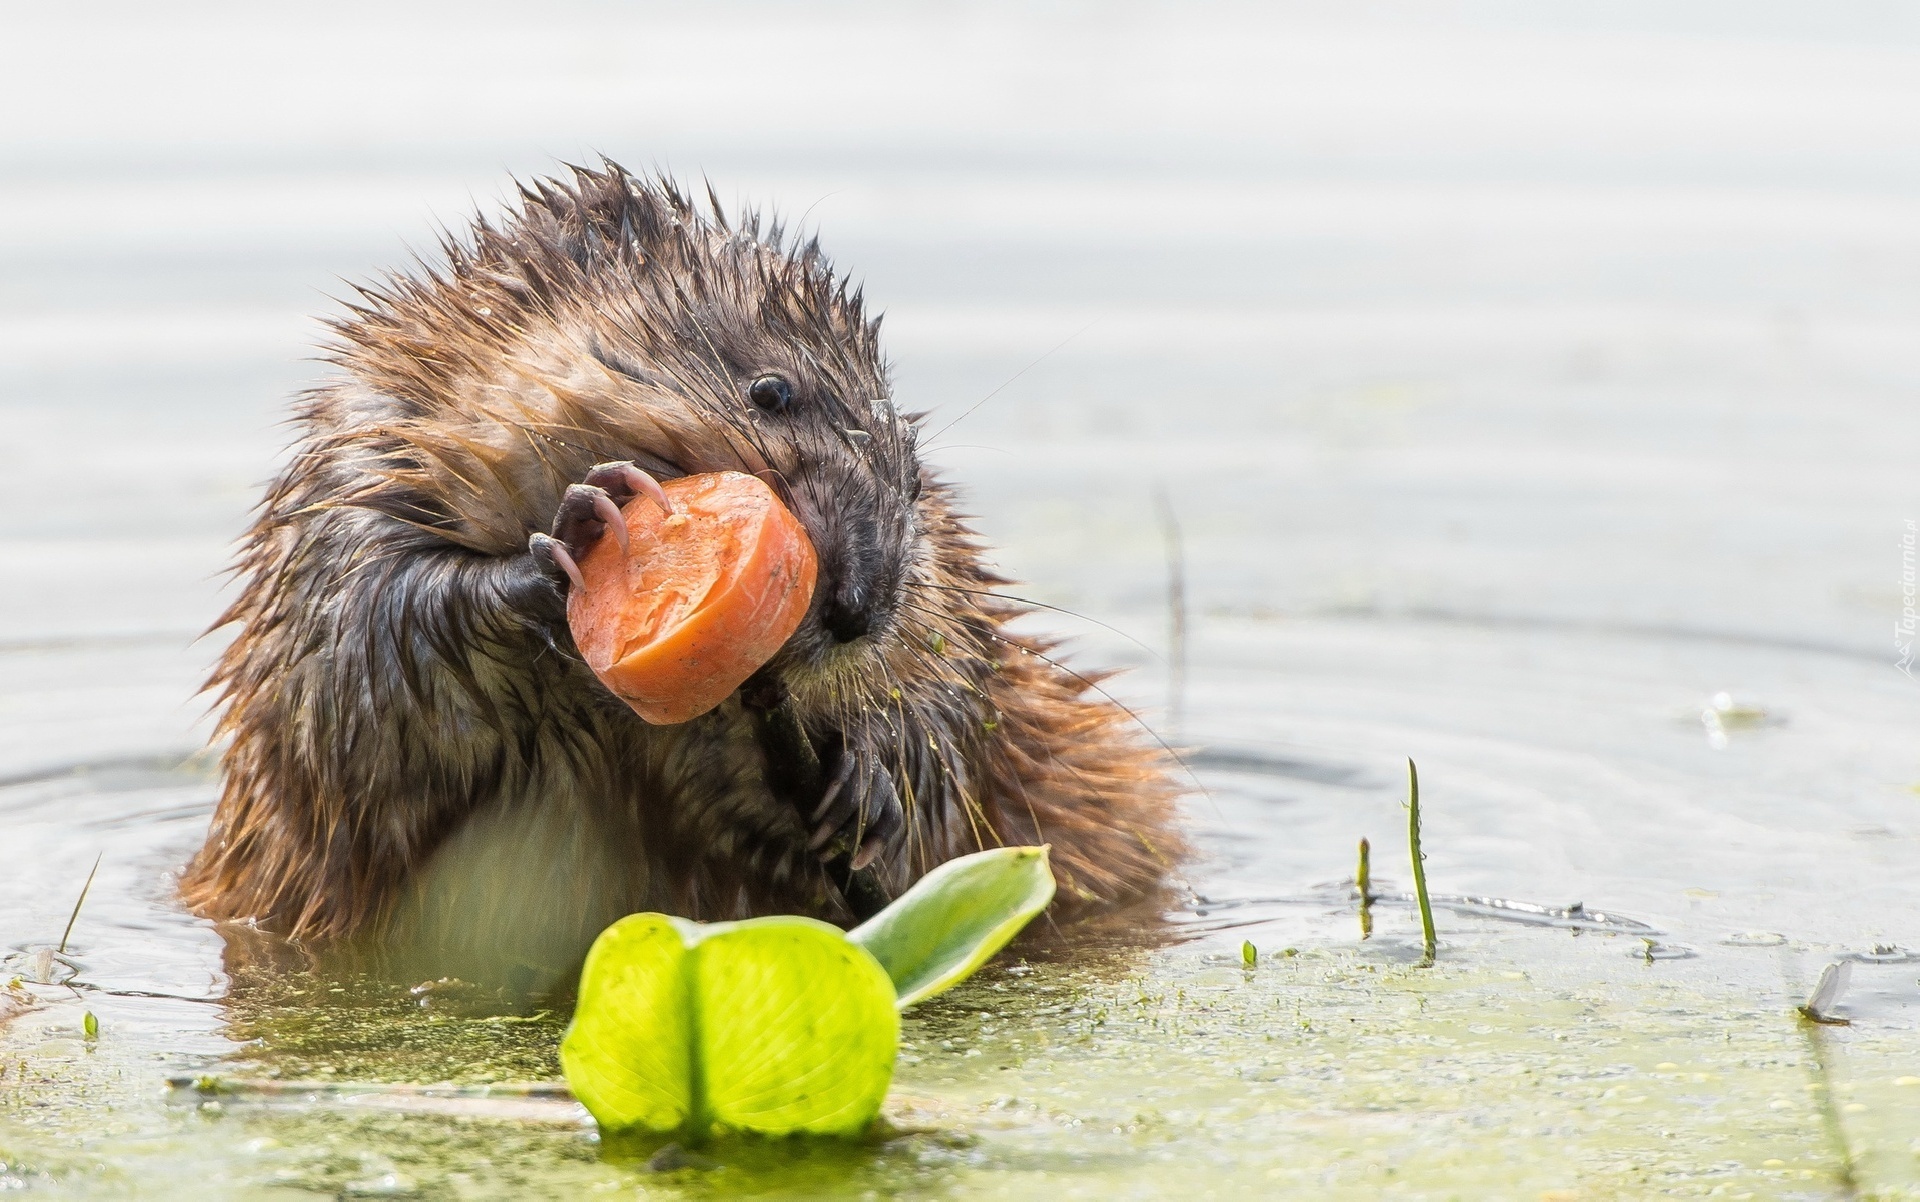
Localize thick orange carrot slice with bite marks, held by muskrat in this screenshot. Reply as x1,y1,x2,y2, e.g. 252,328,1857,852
566,472,818,726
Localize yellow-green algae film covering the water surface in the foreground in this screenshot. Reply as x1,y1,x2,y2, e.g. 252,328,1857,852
0,917,1920,1198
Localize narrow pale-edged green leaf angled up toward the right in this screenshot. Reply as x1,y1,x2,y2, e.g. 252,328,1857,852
847,847,1054,1010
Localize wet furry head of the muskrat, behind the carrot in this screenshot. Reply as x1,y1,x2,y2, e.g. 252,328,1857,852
336,163,941,706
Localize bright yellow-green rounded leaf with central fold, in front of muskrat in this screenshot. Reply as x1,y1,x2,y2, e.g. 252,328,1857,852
561,914,900,1139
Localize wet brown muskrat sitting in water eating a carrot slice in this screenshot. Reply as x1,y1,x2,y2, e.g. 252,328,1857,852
182,163,1185,972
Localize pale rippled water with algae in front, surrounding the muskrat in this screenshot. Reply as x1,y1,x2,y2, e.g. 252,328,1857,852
0,4,1920,1198
